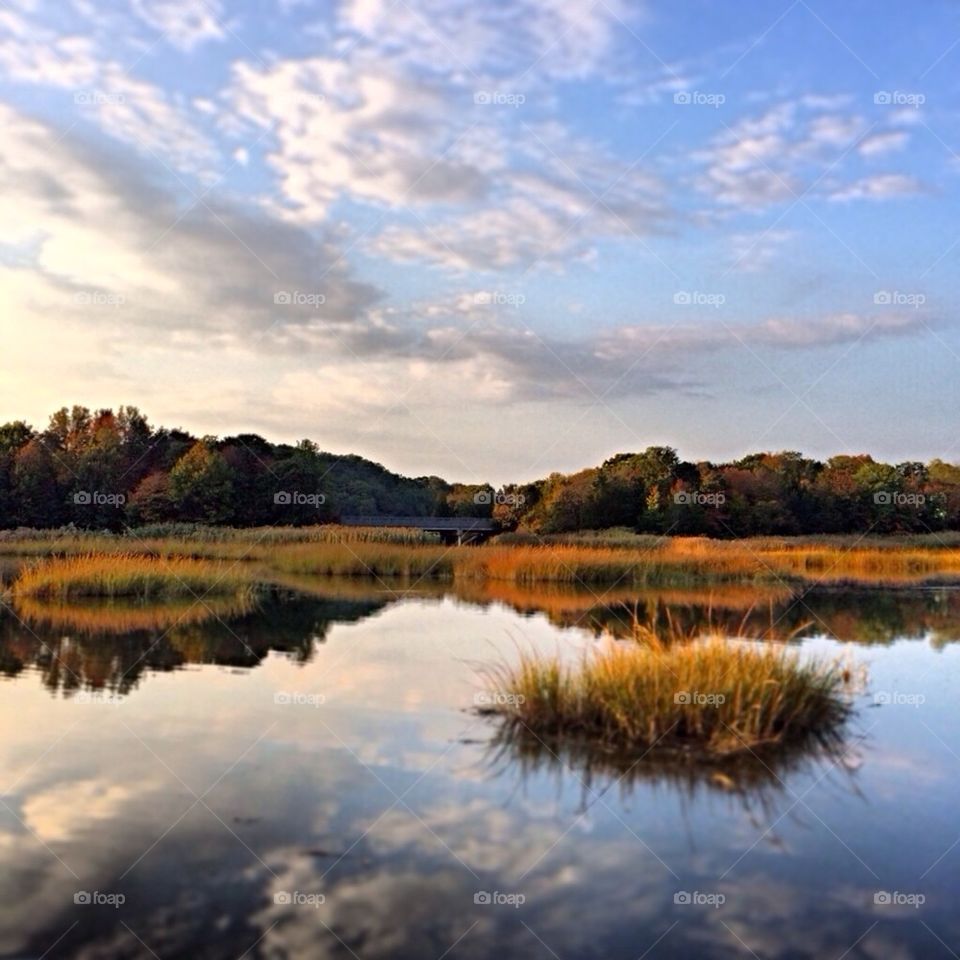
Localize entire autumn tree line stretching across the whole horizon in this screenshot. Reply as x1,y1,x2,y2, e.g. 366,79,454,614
0,406,960,537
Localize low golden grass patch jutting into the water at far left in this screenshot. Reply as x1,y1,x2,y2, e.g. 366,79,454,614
11,554,255,600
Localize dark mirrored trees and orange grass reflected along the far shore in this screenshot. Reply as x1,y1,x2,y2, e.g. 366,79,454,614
0,578,960,694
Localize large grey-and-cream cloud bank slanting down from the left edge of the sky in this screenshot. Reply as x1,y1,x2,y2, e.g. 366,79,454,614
0,108,380,342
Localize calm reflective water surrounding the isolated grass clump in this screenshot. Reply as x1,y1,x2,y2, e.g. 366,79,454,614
0,583,960,960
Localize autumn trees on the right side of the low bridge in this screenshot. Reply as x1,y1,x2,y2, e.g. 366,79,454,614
503,447,960,537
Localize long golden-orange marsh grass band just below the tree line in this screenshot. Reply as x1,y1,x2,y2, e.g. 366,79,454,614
0,525,960,587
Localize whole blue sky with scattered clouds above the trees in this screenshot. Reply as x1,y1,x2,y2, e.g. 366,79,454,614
0,0,960,482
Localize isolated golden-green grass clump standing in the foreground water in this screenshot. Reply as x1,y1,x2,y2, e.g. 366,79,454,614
488,636,851,760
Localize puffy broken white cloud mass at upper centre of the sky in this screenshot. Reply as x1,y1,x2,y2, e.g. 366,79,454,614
230,58,670,271
